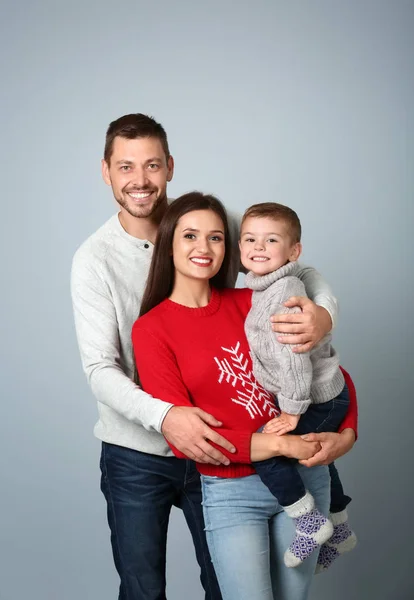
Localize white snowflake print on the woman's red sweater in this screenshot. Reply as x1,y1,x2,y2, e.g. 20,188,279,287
214,342,279,419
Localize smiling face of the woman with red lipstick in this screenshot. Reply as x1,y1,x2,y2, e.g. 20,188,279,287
172,210,225,283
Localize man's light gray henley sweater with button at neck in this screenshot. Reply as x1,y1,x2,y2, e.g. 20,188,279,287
71,215,337,456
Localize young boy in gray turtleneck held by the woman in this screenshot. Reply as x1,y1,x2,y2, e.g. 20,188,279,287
240,202,356,571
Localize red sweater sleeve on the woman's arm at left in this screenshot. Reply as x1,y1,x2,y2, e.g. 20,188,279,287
132,326,252,464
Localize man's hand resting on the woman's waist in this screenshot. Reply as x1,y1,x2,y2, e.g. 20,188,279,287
161,406,236,465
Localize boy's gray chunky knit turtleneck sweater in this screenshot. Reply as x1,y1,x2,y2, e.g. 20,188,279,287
245,262,345,415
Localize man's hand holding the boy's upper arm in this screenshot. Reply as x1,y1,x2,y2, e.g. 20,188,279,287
270,296,332,354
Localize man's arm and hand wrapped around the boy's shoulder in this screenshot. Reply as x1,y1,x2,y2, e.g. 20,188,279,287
271,266,338,353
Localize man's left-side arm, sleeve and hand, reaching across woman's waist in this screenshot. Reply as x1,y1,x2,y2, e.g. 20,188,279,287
71,254,236,464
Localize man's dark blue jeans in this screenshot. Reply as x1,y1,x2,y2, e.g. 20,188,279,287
100,442,221,600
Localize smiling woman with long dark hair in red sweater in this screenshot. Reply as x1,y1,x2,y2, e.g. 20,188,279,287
132,192,352,600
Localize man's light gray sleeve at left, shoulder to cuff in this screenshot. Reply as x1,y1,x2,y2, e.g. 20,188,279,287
71,251,172,433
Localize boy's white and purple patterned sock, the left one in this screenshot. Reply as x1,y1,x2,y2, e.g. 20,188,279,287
283,492,333,567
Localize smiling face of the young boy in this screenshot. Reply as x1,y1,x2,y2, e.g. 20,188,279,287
239,217,302,275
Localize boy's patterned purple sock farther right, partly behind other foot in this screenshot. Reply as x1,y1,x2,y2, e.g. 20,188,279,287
315,509,357,573
